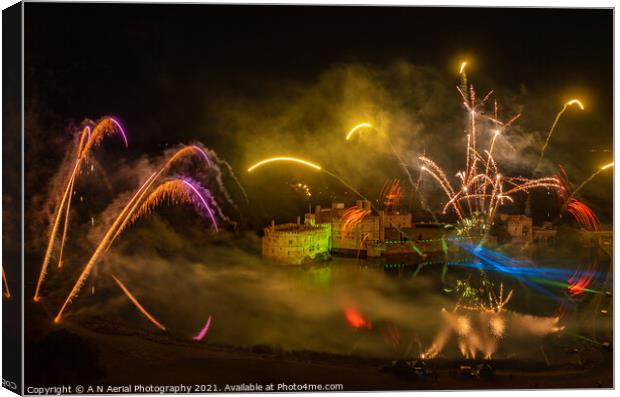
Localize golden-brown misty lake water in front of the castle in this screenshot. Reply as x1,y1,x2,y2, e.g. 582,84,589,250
31,215,588,358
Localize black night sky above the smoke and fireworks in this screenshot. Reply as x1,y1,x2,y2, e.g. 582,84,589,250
25,3,613,223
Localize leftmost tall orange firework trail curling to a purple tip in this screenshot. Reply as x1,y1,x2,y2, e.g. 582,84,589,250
33,117,127,302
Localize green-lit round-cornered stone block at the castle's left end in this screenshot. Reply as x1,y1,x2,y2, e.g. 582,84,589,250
263,217,331,265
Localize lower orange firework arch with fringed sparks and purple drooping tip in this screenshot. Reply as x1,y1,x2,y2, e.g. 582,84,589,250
54,179,217,323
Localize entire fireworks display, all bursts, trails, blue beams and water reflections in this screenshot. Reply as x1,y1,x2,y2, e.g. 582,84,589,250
34,69,613,366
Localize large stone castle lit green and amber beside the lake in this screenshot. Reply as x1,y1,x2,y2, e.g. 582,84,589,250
263,200,457,264
